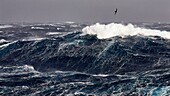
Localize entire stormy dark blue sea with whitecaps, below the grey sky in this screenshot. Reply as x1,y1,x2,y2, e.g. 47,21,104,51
0,22,170,96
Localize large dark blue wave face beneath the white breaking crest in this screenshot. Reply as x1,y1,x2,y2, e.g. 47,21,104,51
0,32,170,74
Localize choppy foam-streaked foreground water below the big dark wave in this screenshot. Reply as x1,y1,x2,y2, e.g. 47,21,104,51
0,65,170,96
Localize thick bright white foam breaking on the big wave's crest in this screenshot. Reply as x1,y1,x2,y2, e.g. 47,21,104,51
82,23,170,39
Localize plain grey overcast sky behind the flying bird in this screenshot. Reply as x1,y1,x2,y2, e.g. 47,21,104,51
0,0,170,23
